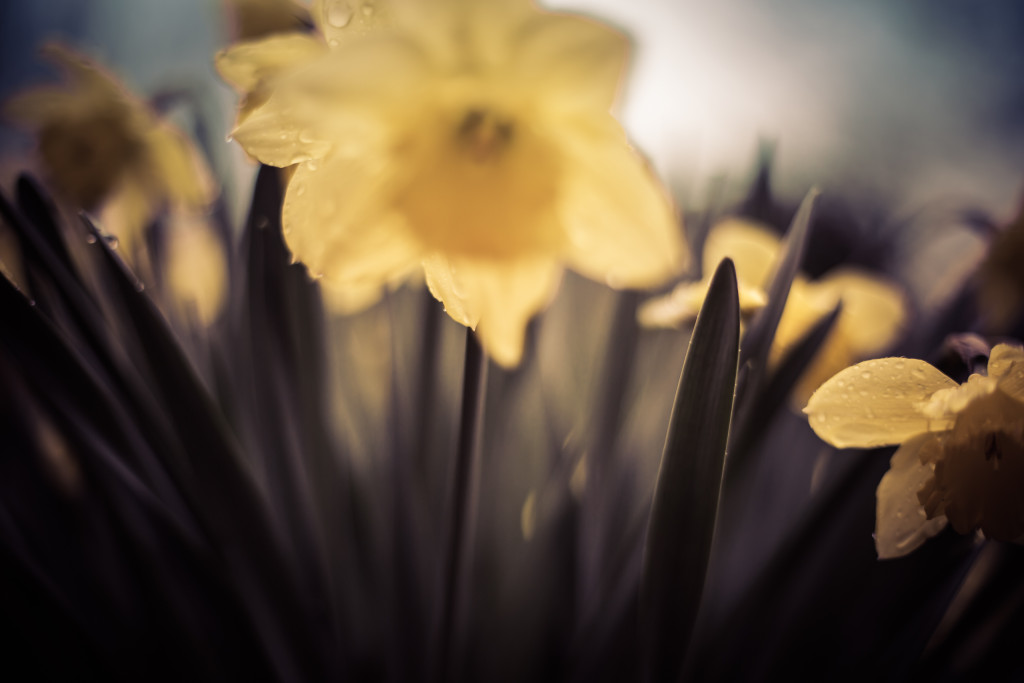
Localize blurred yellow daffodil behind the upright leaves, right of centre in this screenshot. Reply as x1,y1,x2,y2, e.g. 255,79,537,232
639,218,906,405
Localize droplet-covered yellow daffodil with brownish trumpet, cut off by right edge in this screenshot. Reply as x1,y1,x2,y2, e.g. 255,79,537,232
805,344,1024,558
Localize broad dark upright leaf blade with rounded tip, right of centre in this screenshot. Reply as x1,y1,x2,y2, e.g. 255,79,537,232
640,259,739,681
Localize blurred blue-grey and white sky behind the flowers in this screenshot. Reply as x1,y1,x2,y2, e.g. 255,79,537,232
6,0,1024,216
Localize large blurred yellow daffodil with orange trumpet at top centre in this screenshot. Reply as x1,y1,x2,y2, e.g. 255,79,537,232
218,0,686,366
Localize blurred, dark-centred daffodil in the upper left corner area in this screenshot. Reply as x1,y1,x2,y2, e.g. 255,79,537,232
6,45,213,254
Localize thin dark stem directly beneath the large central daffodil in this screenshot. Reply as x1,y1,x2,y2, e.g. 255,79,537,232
435,329,487,682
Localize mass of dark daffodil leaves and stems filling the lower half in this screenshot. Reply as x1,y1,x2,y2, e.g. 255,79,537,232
0,160,1024,681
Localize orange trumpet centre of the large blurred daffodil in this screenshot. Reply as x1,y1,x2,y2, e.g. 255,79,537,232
396,102,565,258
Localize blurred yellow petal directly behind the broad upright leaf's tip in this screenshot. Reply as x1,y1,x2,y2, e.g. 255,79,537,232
701,217,781,290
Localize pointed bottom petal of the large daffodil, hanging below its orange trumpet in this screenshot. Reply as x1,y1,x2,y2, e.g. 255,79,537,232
427,258,561,368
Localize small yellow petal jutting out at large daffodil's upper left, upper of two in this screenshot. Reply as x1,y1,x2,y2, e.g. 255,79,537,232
214,33,327,92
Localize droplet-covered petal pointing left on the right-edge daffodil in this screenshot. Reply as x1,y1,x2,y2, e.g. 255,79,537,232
804,358,956,449
